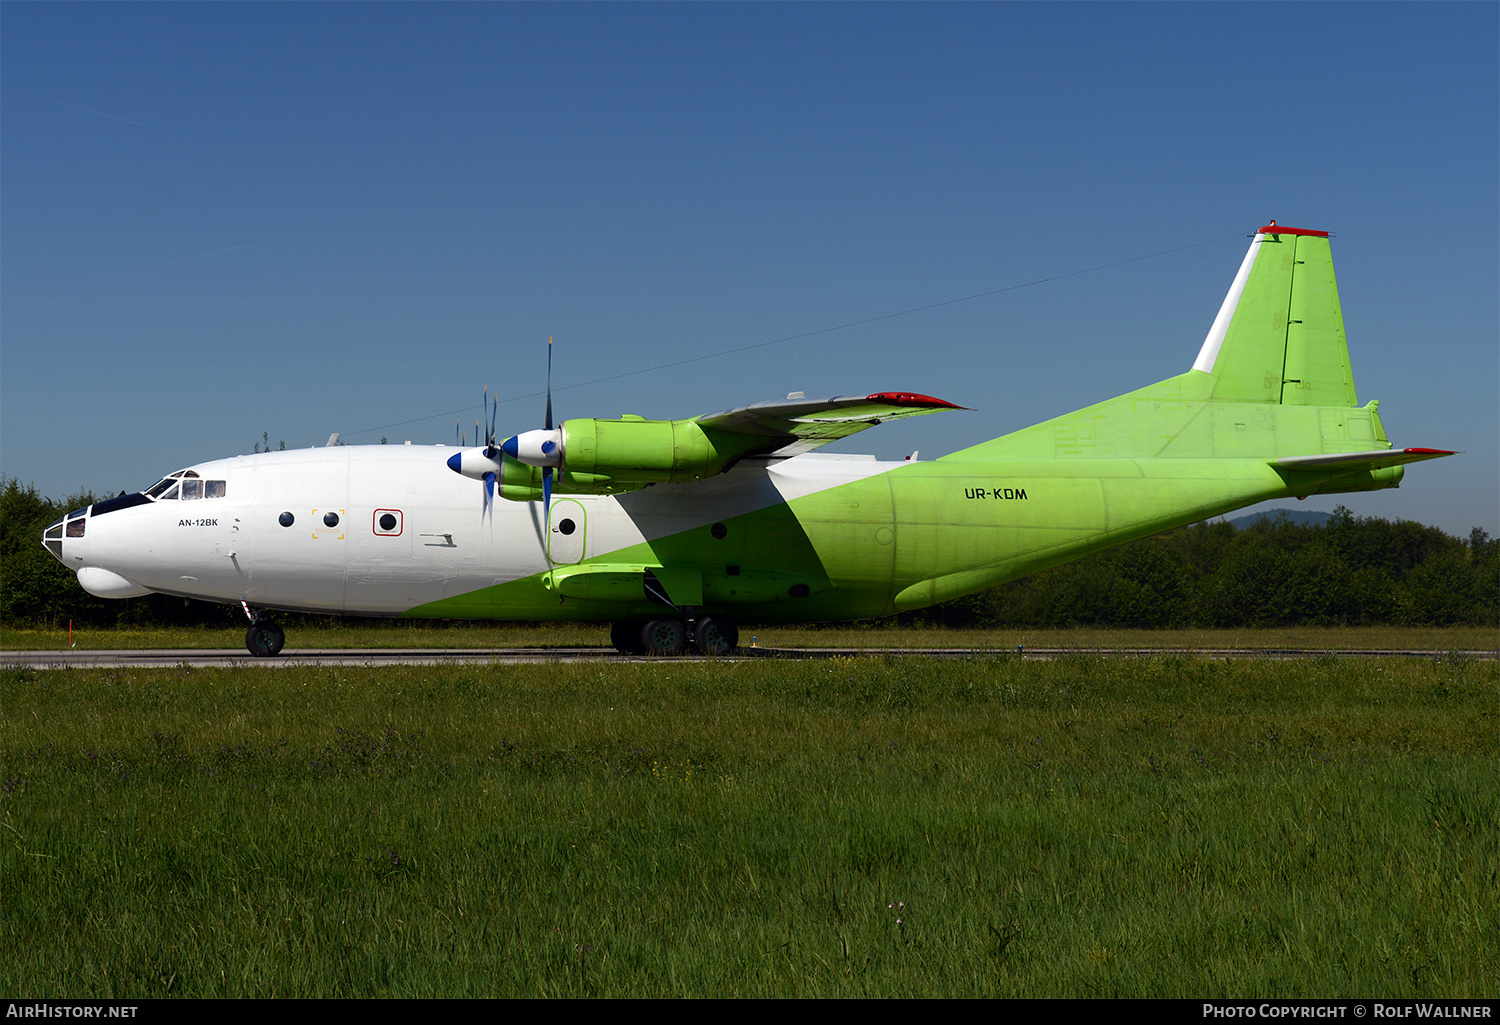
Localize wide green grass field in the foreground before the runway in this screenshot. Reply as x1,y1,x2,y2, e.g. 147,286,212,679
0,656,1500,998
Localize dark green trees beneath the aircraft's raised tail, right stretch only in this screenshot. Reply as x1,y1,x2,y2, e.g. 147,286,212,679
902,506,1500,629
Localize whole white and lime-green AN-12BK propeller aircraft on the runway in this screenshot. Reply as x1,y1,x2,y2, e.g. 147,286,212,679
42,222,1452,656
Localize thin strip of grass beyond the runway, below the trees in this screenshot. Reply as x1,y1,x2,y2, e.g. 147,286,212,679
0,618,1500,651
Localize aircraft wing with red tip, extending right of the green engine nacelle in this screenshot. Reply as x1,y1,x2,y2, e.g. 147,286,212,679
695,392,968,458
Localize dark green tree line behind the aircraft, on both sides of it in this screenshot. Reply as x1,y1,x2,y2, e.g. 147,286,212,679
0,477,1500,627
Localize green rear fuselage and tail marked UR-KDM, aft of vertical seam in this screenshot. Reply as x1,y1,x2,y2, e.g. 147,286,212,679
882,225,1422,609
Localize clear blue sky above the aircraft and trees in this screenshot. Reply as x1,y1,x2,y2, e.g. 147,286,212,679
0,2,1500,534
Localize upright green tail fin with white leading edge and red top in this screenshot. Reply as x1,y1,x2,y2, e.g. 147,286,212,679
1193,221,1359,407
